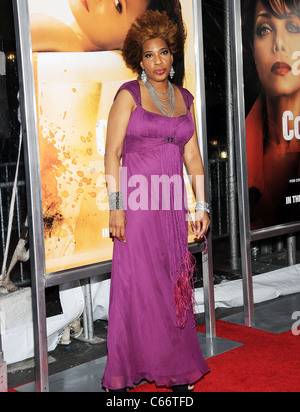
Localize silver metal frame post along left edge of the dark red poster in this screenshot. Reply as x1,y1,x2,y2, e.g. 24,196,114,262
230,0,255,327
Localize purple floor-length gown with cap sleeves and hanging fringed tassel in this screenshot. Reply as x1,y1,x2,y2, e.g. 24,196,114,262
102,81,209,389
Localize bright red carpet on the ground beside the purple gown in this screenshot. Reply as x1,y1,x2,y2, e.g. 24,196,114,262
132,321,300,392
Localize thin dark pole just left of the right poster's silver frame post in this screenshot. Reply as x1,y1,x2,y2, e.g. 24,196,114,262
224,0,239,270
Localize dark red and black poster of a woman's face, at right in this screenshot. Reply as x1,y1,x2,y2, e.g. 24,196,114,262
242,0,300,230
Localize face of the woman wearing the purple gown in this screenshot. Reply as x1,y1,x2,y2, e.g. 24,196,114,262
141,38,173,82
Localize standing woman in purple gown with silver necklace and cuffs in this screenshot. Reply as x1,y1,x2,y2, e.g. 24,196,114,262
102,11,210,392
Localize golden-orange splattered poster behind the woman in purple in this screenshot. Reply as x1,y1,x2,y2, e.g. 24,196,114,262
28,0,196,273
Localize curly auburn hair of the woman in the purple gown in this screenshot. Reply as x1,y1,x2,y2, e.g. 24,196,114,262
122,10,186,83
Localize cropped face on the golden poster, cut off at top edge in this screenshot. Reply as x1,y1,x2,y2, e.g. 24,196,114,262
69,0,150,50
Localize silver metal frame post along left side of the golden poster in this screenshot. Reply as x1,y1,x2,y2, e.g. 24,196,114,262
13,0,49,392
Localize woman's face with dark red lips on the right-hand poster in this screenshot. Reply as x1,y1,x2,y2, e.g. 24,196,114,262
254,0,300,97
